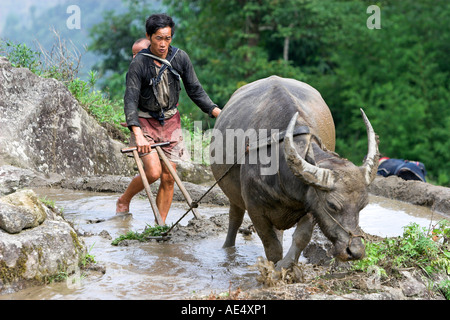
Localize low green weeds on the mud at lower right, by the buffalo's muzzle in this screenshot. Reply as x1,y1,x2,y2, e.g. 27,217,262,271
352,220,450,300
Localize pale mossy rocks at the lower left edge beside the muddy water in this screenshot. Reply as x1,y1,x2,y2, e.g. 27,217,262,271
0,190,86,293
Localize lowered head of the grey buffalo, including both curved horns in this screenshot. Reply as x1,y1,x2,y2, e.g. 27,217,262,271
284,110,379,261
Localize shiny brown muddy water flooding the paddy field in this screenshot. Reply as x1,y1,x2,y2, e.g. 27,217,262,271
0,189,443,299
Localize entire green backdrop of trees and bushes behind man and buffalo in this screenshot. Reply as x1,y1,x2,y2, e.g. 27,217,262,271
3,0,450,186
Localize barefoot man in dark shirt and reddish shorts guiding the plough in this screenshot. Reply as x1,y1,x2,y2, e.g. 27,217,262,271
116,14,220,222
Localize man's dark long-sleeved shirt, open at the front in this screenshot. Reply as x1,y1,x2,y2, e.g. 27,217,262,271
124,48,217,128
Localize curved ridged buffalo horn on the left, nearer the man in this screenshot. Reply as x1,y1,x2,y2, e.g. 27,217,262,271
284,112,334,190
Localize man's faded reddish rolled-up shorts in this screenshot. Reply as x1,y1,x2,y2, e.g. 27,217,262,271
130,112,187,161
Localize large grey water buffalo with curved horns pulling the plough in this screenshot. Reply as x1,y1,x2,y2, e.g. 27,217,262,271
210,76,379,268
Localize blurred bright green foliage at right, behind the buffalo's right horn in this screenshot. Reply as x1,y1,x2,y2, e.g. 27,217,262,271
314,0,450,185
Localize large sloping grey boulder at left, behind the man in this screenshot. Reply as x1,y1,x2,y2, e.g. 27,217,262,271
0,57,133,177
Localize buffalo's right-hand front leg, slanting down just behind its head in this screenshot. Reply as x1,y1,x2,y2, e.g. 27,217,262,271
276,213,314,270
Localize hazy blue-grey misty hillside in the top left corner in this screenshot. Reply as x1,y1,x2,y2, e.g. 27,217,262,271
0,0,130,77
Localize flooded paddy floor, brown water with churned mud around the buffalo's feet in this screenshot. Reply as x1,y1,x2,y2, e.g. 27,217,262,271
0,172,449,300
